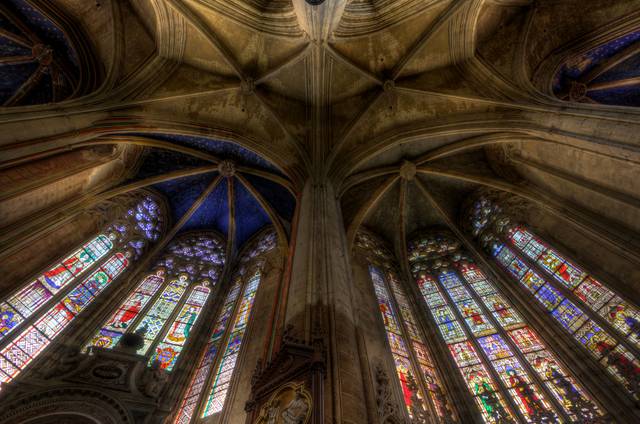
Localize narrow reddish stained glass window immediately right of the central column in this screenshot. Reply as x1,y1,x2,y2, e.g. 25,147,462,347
355,230,450,419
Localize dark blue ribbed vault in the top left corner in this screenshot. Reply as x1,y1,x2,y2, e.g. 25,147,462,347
0,0,97,106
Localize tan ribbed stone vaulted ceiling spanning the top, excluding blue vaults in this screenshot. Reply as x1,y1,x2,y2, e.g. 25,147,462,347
0,0,640,284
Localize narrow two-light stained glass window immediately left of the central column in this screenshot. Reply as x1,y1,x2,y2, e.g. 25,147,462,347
174,229,277,423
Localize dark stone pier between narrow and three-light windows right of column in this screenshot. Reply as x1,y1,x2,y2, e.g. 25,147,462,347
403,267,484,423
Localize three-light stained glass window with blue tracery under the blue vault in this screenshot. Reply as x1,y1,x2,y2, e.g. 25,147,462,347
88,232,224,371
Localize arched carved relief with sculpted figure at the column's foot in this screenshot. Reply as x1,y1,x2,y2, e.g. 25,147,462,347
256,382,313,424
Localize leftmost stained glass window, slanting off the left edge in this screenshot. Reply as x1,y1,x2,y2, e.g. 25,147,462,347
0,195,162,382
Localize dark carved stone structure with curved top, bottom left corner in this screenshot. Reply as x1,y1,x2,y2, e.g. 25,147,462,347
0,347,170,424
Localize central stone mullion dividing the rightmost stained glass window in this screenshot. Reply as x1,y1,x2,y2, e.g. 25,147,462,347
497,230,640,358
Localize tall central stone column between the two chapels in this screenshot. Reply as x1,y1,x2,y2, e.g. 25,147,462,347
284,181,367,423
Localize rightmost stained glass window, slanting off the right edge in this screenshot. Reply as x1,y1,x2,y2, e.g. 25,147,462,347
465,197,640,398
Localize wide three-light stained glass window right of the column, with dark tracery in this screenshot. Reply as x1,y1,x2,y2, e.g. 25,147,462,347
409,232,602,422
